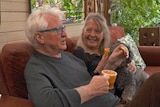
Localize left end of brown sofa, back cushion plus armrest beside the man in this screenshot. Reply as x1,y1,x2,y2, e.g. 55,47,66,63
0,42,34,107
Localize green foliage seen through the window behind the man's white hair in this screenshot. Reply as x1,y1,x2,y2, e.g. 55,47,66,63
31,0,83,22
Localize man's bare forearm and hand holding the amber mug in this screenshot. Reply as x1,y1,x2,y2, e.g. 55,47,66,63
75,75,109,104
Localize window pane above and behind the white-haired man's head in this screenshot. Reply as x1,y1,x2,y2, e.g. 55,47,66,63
31,0,83,23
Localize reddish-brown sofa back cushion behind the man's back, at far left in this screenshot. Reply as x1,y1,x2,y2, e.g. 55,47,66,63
1,42,34,98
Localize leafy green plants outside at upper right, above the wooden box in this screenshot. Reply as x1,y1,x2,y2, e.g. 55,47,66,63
111,0,160,45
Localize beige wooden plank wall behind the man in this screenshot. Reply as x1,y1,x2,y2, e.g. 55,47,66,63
0,0,82,51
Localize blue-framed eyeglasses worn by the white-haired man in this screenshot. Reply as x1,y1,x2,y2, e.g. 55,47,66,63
38,25,66,35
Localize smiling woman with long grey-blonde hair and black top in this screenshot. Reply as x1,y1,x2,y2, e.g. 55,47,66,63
74,13,136,75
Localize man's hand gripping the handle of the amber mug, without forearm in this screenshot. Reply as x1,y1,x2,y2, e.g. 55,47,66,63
88,75,109,96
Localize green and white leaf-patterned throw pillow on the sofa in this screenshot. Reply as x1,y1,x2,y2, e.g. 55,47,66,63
118,34,146,70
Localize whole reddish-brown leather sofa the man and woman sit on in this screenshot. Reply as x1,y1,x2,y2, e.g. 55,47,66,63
0,28,160,107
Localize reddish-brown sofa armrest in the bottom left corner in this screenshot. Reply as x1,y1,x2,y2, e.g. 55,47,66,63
0,96,34,107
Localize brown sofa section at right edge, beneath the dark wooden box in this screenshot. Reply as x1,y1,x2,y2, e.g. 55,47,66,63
138,46,160,66
